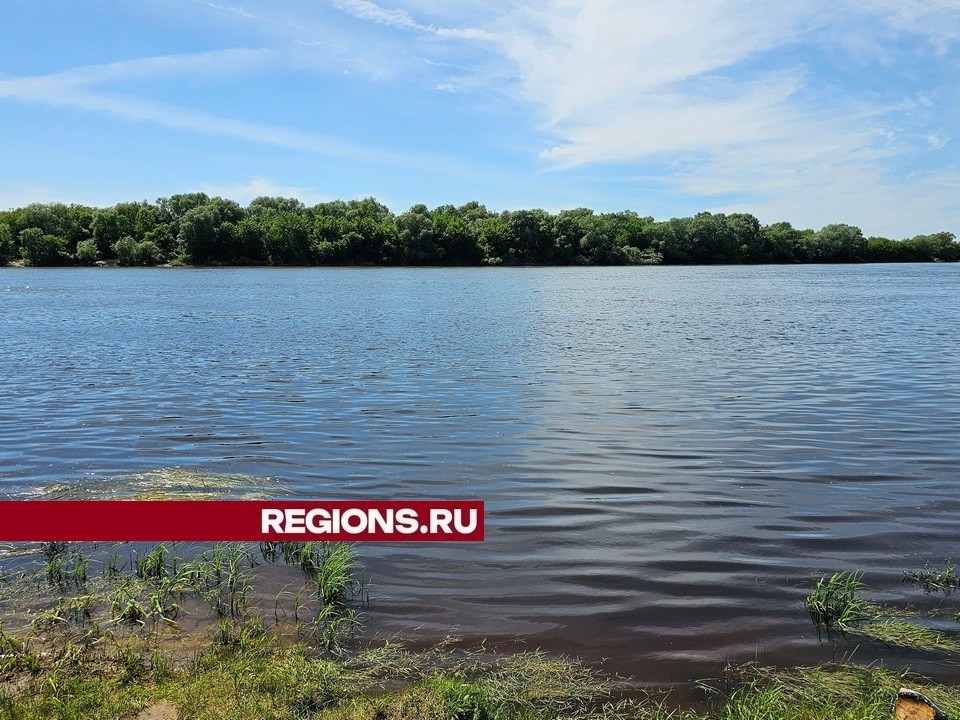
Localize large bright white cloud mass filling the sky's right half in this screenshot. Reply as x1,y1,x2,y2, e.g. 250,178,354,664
460,0,960,234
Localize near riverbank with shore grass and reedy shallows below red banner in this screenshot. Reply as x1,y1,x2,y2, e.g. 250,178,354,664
0,543,960,720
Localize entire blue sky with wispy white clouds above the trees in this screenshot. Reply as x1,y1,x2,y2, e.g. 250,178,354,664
0,0,960,238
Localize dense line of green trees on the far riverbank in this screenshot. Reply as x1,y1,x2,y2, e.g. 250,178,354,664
0,193,960,265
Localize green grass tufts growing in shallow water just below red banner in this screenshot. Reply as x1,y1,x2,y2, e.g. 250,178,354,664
0,543,364,652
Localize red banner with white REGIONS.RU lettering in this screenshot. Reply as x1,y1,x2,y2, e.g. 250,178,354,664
0,500,483,542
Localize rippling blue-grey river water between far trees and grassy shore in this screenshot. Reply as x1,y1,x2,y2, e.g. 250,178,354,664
0,265,960,682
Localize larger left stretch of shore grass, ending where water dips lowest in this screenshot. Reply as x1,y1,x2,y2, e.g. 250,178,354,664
0,616,610,720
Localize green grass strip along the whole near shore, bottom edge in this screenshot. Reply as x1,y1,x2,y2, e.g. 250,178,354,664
0,636,960,720
